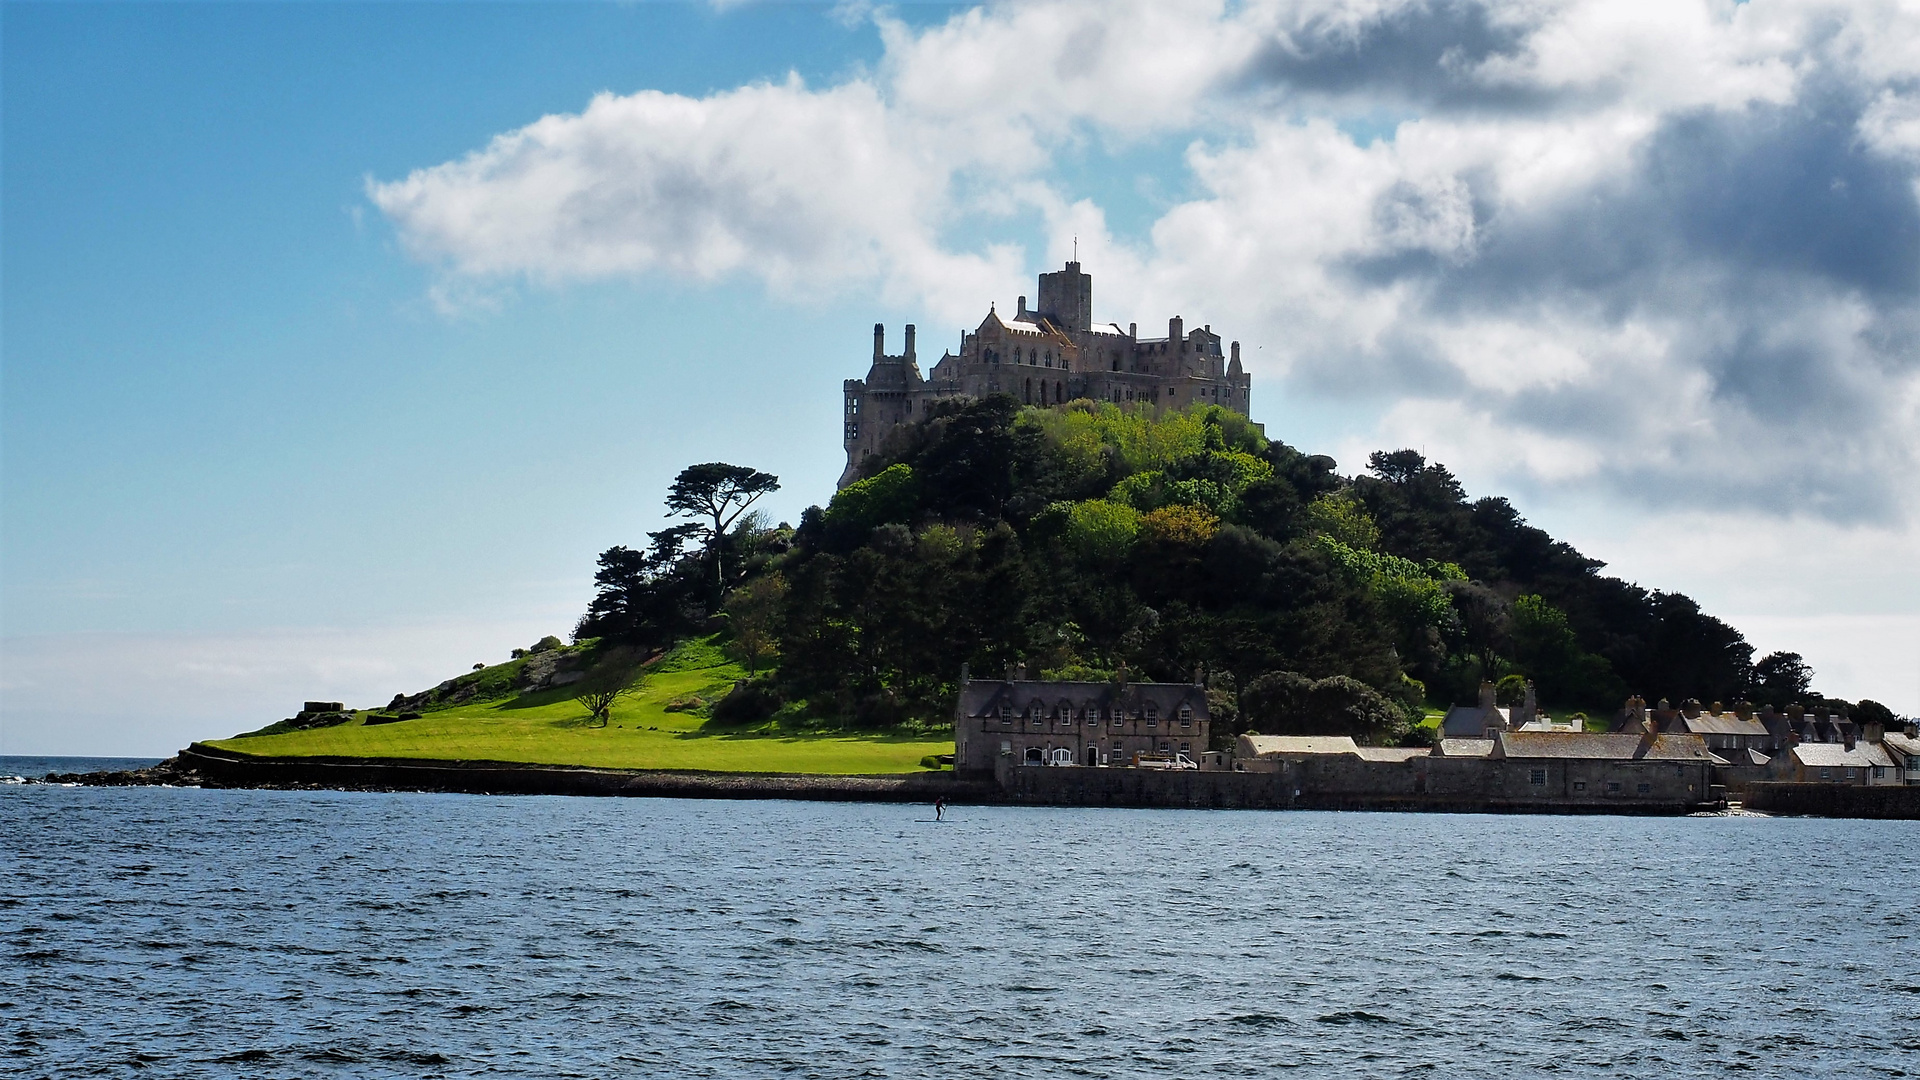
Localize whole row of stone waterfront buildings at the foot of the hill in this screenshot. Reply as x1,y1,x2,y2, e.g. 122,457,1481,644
954,667,1920,805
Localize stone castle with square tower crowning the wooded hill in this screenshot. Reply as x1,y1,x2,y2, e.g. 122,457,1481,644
839,261,1252,488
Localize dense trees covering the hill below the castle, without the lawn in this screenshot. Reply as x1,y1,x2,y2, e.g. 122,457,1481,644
578,398,1858,742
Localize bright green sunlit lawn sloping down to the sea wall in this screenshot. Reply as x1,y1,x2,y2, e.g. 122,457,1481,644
209,641,954,774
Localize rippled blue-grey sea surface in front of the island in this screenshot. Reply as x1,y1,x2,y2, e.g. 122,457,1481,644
0,759,1920,1078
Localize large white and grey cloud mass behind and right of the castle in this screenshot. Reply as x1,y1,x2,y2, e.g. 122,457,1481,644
369,0,1920,523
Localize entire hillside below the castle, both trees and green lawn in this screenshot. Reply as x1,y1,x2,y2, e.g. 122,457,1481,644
223,396,1885,760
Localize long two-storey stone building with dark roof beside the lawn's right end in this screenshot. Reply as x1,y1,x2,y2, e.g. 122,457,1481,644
954,669,1212,771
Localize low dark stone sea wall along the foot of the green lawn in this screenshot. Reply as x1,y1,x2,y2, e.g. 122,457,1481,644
179,742,1000,803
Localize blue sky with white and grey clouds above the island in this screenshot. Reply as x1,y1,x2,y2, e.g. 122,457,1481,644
0,0,1920,753
